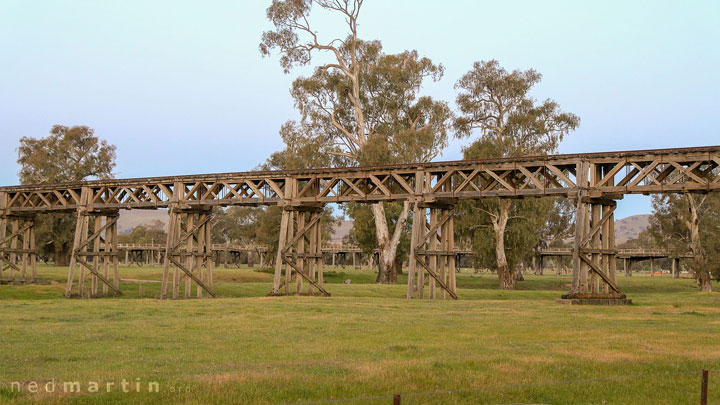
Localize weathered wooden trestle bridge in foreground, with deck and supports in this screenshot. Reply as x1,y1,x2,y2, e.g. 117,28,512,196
0,146,720,300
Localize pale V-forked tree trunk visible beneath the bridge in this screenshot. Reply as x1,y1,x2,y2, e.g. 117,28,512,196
372,201,410,284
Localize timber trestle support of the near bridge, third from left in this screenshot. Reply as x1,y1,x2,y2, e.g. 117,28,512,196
160,205,215,299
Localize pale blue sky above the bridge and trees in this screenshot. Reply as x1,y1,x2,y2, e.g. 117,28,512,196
0,0,720,217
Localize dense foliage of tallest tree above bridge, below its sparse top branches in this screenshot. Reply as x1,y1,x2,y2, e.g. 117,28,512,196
272,39,452,167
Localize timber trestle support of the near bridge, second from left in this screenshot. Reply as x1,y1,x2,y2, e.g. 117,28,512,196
65,194,122,298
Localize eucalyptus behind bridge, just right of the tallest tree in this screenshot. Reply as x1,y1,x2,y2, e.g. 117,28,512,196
455,60,580,289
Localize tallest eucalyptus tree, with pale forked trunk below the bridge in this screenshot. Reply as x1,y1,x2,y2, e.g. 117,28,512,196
260,0,452,283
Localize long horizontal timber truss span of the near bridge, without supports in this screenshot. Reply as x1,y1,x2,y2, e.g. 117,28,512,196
0,146,720,211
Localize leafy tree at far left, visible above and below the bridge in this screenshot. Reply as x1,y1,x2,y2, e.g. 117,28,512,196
17,125,115,265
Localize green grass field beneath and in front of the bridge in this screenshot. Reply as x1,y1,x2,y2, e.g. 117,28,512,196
0,266,720,404
